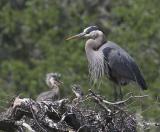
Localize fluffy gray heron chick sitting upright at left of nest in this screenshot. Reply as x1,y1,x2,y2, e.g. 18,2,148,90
36,73,61,101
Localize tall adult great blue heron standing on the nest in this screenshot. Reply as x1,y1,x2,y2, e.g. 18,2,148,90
67,26,147,98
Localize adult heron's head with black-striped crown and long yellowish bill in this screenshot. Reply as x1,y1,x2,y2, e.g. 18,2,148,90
67,26,103,40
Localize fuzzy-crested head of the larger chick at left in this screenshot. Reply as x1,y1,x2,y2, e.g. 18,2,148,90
46,72,62,88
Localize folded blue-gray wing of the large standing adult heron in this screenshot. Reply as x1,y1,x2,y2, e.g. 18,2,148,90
103,42,147,89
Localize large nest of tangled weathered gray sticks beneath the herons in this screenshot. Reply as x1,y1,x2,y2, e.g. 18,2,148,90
0,90,158,132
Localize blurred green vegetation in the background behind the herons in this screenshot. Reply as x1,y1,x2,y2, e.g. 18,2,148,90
0,0,160,129
